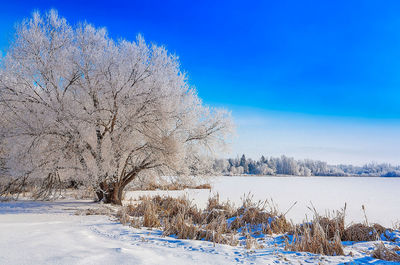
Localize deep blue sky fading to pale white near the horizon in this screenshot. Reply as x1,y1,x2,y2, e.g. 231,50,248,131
0,0,400,164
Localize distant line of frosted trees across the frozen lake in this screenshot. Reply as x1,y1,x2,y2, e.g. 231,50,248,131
213,155,400,177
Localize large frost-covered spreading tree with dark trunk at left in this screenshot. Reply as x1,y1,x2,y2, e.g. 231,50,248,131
0,10,232,204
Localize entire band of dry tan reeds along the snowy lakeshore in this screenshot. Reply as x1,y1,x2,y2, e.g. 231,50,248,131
118,194,396,256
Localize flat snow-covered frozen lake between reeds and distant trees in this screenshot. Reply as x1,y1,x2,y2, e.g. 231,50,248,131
126,176,400,227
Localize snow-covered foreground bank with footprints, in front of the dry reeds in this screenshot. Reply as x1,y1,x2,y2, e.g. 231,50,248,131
0,201,396,265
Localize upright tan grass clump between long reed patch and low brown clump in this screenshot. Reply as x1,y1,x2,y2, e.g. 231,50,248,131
285,223,344,256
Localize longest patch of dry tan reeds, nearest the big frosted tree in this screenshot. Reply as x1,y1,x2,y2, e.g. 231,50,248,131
118,194,292,248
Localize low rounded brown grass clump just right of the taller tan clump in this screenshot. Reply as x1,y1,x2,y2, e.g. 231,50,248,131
342,223,387,242
